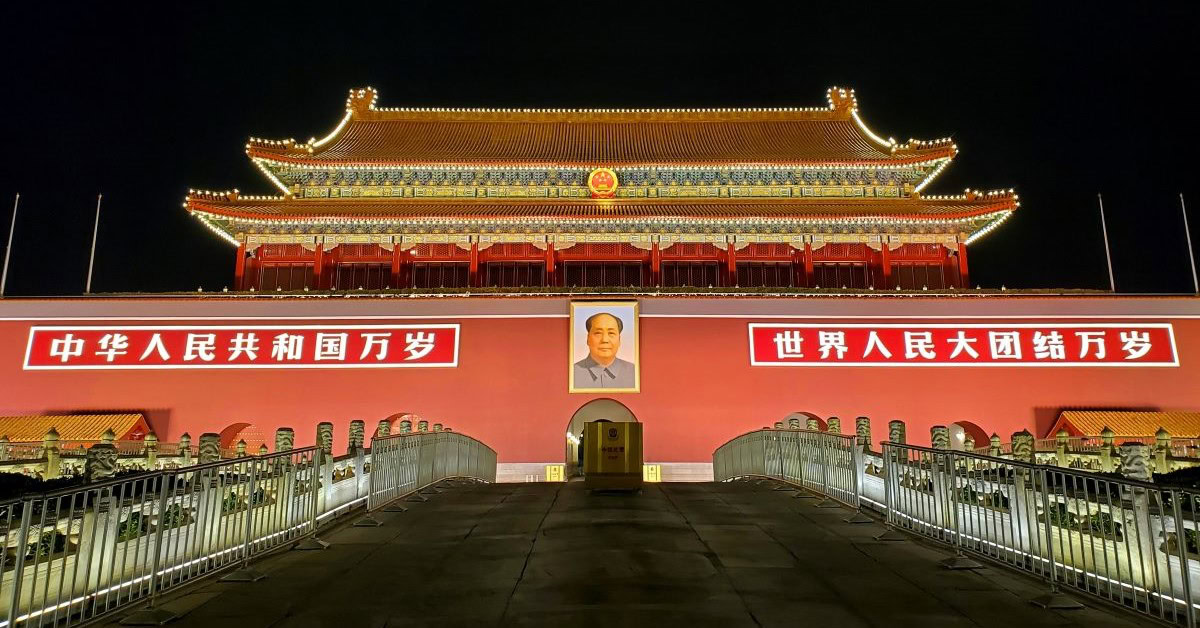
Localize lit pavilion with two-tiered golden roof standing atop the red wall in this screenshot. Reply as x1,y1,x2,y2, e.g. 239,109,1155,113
186,88,1018,291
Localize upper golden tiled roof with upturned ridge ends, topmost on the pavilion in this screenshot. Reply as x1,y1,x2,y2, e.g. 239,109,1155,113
246,88,956,166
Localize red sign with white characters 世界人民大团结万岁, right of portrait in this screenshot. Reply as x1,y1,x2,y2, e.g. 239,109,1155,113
749,323,1180,366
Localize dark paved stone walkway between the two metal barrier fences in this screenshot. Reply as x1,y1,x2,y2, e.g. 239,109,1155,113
105,483,1139,628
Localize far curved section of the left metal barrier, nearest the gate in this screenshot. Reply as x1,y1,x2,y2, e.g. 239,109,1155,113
367,432,496,512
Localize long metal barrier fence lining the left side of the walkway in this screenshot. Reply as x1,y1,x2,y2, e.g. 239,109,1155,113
0,432,496,628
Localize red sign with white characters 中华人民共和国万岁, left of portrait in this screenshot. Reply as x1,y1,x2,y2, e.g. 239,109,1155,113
24,324,460,371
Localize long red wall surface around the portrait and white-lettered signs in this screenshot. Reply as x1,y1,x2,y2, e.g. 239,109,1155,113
0,298,1200,462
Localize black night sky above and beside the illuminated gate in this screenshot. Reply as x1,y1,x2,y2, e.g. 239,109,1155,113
0,1,1200,295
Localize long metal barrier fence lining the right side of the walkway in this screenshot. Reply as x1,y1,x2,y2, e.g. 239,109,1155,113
713,430,1200,627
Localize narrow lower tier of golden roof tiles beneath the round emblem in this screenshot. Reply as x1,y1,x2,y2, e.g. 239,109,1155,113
187,196,1016,221
